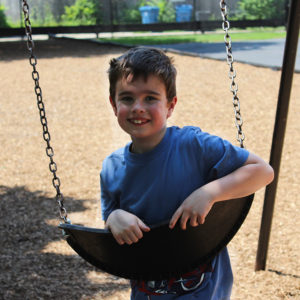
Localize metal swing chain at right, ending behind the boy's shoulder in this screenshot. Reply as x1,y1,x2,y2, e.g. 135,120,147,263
220,0,245,148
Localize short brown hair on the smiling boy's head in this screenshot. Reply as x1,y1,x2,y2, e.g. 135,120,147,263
108,47,177,101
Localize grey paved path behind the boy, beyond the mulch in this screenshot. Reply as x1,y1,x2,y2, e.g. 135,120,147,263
156,39,300,72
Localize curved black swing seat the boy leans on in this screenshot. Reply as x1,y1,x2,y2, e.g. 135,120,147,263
59,195,253,280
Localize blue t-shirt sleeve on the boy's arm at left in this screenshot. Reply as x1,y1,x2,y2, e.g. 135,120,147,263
100,159,119,221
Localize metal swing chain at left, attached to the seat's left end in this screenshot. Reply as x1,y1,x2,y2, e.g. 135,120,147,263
22,0,70,223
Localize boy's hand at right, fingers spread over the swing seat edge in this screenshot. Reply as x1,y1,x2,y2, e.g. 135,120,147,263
169,188,214,230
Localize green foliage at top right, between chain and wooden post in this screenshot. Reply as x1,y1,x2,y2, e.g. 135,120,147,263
236,0,285,20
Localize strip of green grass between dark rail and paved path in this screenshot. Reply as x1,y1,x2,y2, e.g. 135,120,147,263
99,29,286,45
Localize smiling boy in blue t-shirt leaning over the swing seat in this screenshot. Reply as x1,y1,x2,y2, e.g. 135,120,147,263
101,47,273,300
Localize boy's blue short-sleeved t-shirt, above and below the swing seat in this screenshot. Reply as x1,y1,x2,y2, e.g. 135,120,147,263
101,126,249,300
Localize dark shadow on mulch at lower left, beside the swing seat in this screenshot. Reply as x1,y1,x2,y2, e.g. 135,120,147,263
0,186,128,300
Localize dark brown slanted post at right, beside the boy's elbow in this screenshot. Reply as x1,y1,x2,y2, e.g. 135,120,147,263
255,0,300,271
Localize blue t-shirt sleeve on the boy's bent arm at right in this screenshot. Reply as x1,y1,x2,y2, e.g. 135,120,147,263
191,127,249,182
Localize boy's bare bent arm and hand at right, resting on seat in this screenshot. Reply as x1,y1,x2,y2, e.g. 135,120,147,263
170,153,274,229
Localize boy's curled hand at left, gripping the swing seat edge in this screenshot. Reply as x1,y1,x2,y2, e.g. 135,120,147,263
106,209,150,245
